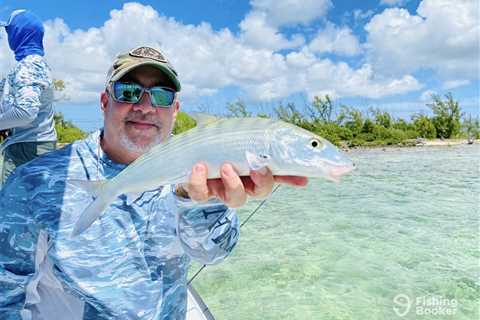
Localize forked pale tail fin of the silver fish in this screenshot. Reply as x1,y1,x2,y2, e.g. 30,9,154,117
69,180,116,238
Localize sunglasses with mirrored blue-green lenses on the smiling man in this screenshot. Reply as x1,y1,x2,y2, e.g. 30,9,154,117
109,81,175,108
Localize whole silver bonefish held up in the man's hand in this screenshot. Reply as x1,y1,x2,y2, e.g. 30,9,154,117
72,115,354,236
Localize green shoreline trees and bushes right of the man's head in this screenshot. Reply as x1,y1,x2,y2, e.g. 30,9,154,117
175,93,480,147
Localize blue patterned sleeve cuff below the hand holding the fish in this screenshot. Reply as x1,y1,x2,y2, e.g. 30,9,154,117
177,197,239,264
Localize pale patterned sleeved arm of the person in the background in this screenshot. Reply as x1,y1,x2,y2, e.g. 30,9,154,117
0,63,45,130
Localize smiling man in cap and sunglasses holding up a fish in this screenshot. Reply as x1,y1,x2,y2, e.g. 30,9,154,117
0,47,306,320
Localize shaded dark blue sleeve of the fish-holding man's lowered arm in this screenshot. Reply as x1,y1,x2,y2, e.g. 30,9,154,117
0,170,39,320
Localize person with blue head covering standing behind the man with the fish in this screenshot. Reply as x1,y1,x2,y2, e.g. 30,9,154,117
0,10,57,186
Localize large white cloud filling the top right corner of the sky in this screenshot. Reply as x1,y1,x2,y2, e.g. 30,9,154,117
365,0,480,80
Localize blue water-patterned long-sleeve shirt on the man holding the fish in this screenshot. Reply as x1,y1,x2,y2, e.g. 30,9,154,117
0,132,239,320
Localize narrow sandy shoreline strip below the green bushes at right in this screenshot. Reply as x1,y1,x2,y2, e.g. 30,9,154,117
341,139,480,152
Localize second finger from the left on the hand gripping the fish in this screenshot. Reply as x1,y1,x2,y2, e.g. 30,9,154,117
220,163,247,208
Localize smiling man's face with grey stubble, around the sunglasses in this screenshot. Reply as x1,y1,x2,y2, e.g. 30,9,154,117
101,66,180,163
